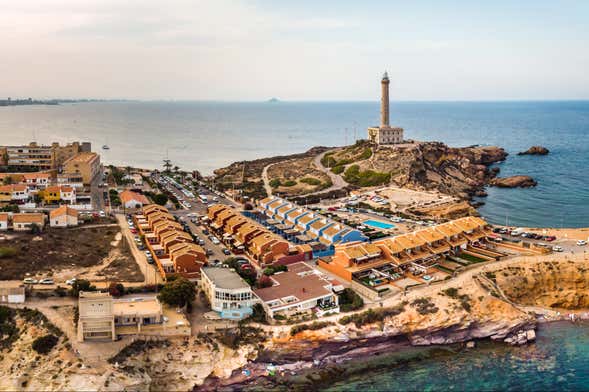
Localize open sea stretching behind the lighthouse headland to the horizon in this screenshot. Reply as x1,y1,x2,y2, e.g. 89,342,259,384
0,101,589,227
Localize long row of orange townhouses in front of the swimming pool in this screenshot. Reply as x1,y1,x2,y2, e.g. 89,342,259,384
318,217,490,281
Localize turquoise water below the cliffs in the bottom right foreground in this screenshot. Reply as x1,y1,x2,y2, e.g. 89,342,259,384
322,322,589,392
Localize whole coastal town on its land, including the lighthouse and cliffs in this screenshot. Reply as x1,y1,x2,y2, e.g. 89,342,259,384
0,73,589,390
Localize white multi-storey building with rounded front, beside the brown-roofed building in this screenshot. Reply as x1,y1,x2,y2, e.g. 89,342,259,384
200,267,257,320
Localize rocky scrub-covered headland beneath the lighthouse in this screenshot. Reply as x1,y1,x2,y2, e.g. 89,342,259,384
210,141,532,200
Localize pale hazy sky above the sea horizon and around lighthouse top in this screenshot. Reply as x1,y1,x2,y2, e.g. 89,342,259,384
0,0,589,100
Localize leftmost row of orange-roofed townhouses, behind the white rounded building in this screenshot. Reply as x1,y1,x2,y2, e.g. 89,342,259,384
133,204,207,280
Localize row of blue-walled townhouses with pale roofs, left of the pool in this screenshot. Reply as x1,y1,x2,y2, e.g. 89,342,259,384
258,197,367,247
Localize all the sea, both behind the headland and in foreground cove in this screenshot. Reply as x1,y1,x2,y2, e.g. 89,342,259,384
0,101,589,391
